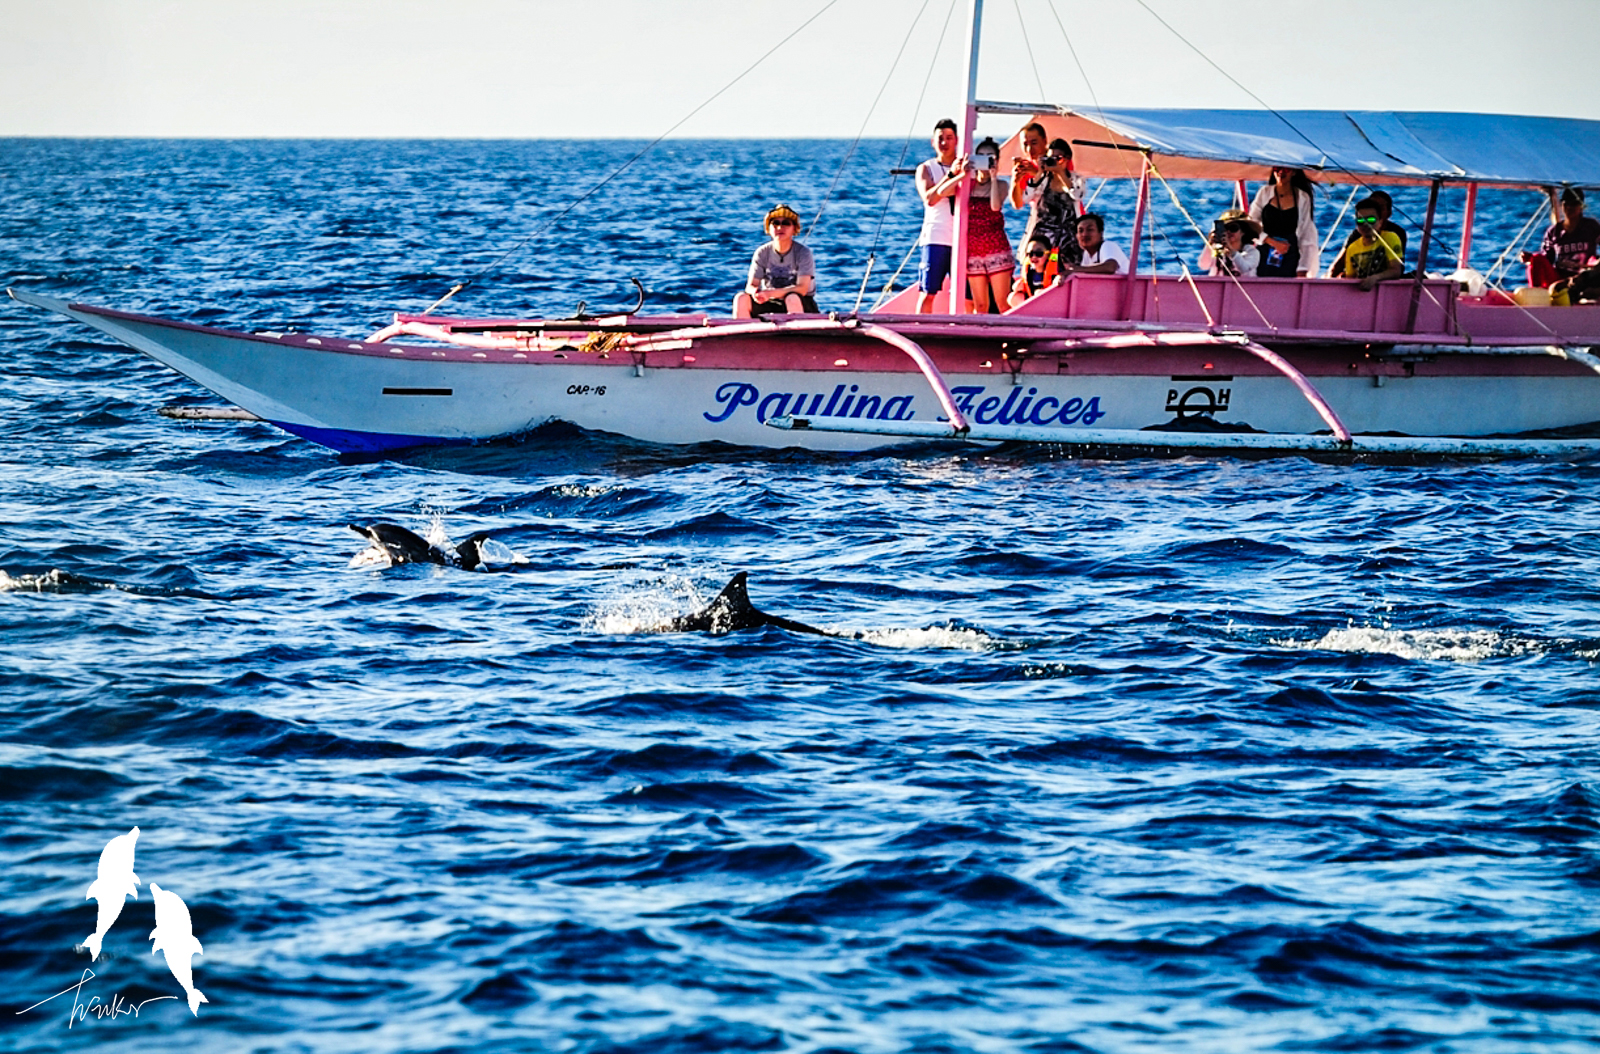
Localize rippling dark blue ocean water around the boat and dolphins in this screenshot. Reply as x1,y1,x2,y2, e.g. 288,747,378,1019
0,141,1600,1054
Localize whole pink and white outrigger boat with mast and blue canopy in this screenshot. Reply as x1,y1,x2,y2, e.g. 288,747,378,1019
11,0,1600,457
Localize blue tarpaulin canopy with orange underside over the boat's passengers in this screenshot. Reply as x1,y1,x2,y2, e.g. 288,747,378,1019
978,102,1600,187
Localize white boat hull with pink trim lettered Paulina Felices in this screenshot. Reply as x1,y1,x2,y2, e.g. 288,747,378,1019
18,294,1600,453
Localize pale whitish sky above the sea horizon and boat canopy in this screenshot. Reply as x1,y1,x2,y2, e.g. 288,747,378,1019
0,0,1600,139
